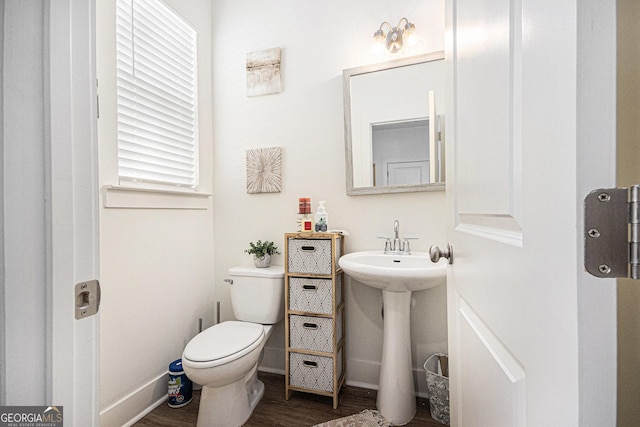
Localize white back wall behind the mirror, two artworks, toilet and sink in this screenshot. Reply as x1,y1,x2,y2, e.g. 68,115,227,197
212,0,447,391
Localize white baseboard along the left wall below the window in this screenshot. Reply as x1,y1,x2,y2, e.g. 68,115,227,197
100,373,168,427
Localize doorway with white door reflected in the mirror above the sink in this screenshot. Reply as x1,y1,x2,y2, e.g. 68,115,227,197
371,118,429,186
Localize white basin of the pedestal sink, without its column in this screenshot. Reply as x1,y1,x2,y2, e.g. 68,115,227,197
338,251,447,292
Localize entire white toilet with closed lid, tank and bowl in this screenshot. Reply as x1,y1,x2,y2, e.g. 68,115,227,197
182,266,284,427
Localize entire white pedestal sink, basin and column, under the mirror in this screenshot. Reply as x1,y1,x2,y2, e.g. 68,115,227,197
338,251,447,425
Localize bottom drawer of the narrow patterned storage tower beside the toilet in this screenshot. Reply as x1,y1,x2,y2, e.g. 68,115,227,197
289,350,342,392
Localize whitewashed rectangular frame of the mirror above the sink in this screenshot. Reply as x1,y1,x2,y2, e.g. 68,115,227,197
342,51,445,196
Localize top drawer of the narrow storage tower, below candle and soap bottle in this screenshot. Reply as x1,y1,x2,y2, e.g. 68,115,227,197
287,239,340,275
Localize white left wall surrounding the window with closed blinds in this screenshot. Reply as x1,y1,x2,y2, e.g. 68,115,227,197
96,0,215,426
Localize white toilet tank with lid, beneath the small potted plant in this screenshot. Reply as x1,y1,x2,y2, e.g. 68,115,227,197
228,265,284,325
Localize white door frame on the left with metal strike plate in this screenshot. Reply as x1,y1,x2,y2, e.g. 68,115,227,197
47,0,100,426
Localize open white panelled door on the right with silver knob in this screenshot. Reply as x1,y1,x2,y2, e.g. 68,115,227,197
445,0,616,427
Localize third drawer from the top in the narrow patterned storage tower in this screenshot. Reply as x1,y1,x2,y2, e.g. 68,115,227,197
289,311,343,353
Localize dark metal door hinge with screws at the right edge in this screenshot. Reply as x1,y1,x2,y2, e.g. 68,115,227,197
584,185,640,279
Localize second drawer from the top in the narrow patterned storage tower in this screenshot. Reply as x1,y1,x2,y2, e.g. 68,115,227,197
289,275,342,314
